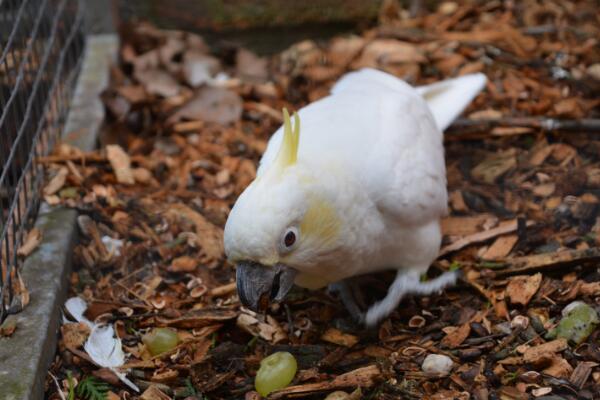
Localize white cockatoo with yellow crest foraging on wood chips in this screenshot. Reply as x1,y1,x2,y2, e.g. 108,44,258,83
224,69,486,326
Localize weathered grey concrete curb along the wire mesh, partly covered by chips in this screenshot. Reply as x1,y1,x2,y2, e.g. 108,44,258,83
0,34,119,400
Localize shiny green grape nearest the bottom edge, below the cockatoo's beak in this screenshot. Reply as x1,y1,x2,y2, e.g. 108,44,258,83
254,351,298,397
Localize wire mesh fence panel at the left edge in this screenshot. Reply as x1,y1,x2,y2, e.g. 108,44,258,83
0,0,84,319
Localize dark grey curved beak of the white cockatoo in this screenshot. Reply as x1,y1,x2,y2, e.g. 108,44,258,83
235,261,297,312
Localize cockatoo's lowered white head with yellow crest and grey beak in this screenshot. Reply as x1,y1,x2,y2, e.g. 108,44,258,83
225,110,340,311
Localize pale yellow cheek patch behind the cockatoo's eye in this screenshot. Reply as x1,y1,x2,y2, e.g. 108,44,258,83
300,198,340,244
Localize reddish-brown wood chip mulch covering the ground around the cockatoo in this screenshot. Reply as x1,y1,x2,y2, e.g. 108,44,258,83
39,0,600,400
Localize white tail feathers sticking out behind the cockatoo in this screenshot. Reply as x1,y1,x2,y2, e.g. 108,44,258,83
417,73,487,131
